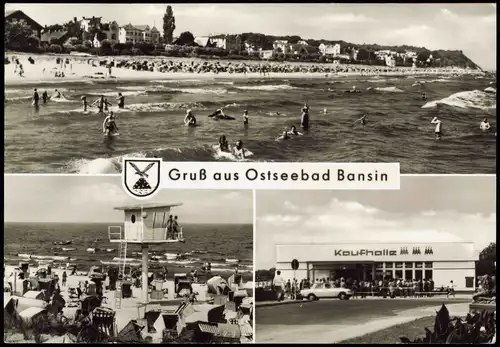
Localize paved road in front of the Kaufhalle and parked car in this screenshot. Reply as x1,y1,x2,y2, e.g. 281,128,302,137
255,299,470,343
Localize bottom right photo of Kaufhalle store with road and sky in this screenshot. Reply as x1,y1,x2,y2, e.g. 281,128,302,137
254,175,496,344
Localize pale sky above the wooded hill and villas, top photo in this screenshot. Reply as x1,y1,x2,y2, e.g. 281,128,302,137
6,3,496,70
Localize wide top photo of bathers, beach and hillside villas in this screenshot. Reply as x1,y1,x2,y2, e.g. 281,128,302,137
4,3,497,174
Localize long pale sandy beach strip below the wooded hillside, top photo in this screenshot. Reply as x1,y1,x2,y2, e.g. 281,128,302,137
1,53,482,86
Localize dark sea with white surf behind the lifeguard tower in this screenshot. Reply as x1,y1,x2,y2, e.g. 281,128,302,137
4,223,253,274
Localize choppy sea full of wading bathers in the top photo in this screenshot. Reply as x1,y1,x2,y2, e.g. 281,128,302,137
4,74,496,174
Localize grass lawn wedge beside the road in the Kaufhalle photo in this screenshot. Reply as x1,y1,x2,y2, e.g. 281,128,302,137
339,315,436,344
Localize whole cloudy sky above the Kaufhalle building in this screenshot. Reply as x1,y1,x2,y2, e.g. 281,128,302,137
255,176,496,269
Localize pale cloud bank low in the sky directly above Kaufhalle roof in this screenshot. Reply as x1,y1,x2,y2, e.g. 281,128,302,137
256,199,496,268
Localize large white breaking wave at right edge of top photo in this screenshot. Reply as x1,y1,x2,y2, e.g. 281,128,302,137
422,90,496,110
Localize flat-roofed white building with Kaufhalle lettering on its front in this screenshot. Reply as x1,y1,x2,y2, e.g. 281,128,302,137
276,242,479,291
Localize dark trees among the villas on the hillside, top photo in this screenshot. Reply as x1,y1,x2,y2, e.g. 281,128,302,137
4,20,478,68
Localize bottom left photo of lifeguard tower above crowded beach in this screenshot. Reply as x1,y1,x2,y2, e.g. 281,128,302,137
3,175,254,343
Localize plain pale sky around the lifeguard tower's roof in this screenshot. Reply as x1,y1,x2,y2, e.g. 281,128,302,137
4,175,253,224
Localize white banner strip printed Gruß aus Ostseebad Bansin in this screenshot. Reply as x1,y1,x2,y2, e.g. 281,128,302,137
161,162,400,190
